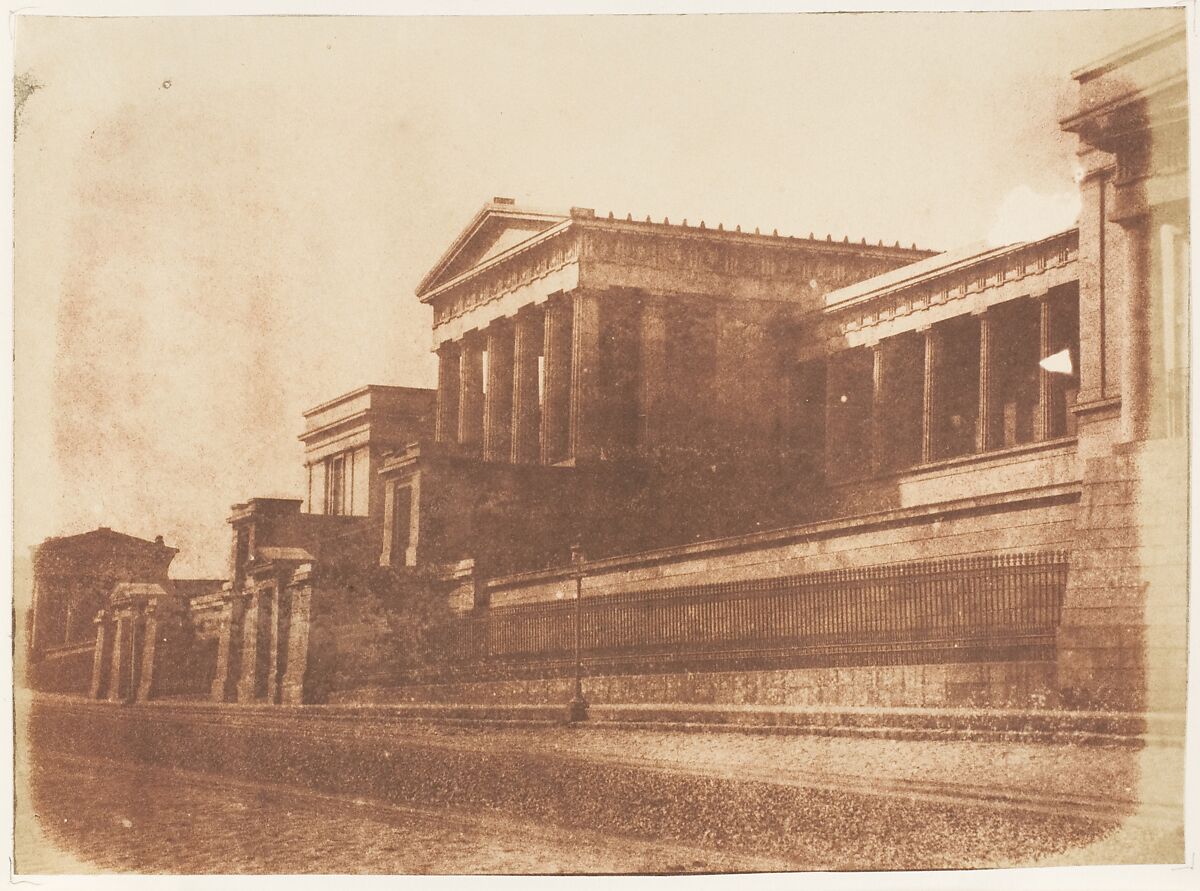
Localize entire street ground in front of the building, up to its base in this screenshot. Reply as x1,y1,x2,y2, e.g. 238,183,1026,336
18,701,1183,873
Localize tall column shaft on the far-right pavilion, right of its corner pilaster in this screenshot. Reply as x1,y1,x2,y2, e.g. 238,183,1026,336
1121,220,1151,442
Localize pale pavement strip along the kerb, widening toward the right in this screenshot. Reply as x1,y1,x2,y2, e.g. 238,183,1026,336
100,706,1183,821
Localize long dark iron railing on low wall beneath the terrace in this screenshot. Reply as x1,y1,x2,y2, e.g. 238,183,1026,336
446,551,1067,668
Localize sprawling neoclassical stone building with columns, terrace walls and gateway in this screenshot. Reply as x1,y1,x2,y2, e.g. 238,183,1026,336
35,22,1189,711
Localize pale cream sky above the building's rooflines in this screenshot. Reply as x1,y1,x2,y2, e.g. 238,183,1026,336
14,10,1182,576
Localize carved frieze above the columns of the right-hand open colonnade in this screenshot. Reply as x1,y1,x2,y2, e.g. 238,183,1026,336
832,231,1079,335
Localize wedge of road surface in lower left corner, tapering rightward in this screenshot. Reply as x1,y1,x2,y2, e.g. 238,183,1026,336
14,755,791,875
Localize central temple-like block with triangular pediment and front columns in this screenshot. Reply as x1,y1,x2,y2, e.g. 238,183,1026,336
418,199,929,465
